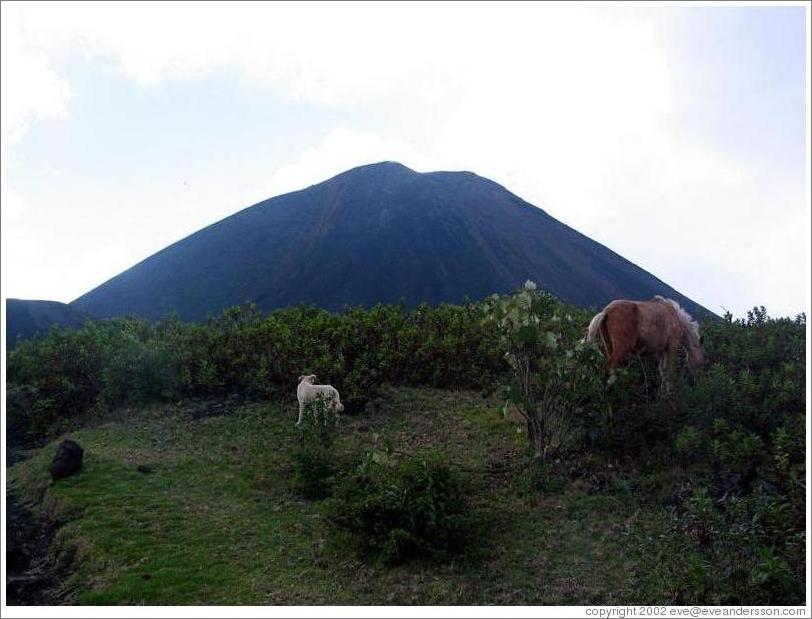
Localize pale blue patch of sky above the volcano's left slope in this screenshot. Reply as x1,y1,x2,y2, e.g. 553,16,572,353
8,58,348,242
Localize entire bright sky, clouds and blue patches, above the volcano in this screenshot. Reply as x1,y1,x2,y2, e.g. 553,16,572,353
0,2,810,316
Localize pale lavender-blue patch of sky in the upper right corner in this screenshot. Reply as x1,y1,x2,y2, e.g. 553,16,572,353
666,7,806,175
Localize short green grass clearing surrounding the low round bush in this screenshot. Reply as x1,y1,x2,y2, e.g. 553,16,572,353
8,388,712,605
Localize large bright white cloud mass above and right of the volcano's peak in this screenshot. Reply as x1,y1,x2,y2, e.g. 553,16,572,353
3,2,808,313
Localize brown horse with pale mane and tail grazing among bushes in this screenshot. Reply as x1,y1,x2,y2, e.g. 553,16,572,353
587,295,705,393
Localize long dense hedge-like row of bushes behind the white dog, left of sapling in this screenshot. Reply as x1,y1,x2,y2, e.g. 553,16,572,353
7,303,503,437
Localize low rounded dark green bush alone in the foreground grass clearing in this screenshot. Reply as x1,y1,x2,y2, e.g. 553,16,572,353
328,452,473,565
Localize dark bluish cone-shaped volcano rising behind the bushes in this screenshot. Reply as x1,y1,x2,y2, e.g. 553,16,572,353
73,162,697,320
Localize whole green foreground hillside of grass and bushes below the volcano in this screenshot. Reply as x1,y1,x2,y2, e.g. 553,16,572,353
7,290,807,604
